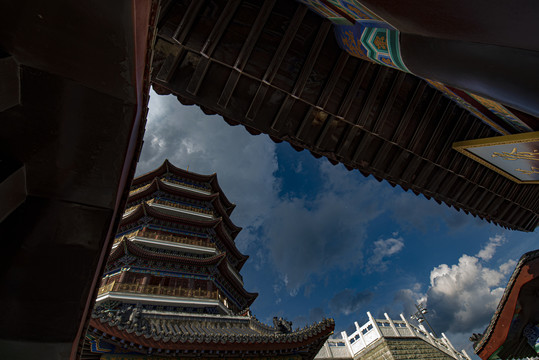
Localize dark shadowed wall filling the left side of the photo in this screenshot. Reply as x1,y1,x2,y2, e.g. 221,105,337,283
0,0,158,359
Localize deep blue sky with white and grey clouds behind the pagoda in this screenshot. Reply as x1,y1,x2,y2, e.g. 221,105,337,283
137,92,538,355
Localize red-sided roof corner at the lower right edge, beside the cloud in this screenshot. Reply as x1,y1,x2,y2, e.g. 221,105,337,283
470,250,539,360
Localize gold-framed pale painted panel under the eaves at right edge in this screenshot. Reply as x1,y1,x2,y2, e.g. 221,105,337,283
453,131,539,184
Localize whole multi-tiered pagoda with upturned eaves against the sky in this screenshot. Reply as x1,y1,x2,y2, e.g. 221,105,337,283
81,160,334,360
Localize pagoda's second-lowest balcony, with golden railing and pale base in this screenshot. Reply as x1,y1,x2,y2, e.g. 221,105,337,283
112,230,217,255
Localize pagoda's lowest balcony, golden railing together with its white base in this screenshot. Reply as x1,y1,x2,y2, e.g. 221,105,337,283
96,281,234,314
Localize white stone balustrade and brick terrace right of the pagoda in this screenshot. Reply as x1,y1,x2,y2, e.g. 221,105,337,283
315,312,471,360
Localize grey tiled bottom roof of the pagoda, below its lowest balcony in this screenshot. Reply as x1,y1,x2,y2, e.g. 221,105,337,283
90,307,335,358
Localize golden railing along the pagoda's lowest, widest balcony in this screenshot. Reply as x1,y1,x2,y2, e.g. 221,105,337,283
97,281,219,304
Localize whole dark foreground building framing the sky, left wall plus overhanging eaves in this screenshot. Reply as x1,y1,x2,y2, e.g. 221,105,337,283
0,0,539,360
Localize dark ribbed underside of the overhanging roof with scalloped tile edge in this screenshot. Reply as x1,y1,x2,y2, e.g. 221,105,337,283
153,0,539,231
